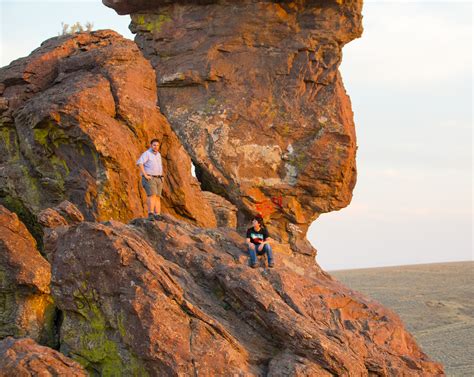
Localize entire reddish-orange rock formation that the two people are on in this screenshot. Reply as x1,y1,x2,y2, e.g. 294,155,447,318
0,0,443,376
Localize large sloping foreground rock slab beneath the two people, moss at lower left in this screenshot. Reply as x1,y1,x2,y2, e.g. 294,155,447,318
46,210,443,376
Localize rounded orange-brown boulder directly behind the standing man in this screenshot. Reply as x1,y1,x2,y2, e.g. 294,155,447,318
0,31,215,226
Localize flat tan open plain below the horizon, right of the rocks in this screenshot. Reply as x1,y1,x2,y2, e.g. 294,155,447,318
330,262,474,376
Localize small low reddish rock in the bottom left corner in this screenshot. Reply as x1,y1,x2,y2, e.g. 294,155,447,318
0,337,87,377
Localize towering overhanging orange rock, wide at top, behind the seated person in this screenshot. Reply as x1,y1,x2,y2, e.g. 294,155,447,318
104,0,362,250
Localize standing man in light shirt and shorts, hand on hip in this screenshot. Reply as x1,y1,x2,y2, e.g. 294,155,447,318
137,139,163,221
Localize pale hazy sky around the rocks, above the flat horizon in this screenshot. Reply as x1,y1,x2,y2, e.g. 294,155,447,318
0,0,473,270
